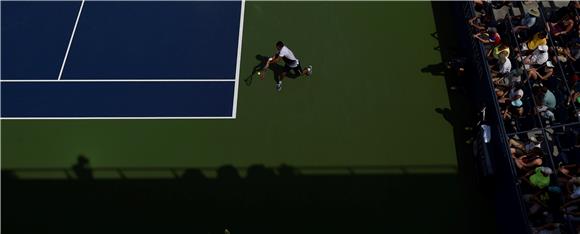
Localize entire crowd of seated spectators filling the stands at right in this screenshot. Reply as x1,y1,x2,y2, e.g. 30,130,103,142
467,1,580,233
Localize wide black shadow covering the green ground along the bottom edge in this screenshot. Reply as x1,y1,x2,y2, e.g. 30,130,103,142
2,164,469,234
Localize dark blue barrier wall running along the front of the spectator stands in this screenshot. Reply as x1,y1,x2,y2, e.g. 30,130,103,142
458,1,530,233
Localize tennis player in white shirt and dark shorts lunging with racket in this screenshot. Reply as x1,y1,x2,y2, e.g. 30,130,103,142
264,41,312,91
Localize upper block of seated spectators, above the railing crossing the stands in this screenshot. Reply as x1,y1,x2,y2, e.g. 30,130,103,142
468,1,580,132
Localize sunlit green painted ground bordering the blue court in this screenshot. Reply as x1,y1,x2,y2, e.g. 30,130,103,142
1,2,456,168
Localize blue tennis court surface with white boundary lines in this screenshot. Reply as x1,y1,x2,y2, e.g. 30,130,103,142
1,1,242,119
